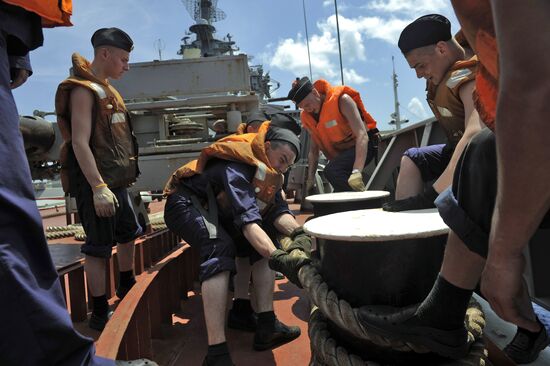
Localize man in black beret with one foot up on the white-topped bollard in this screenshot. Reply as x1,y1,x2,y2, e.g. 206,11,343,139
383,14,482,211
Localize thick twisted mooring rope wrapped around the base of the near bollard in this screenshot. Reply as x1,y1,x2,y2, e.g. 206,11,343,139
299,265,485,365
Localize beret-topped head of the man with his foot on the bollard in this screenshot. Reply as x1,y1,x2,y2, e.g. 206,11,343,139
398,14,461,85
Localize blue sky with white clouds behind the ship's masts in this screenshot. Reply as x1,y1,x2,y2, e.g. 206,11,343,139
14,0,459,130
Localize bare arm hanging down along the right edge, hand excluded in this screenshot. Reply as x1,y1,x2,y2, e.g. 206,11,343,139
490,0,550,255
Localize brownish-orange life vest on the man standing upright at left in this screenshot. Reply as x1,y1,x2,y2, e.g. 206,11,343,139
55,53,139,192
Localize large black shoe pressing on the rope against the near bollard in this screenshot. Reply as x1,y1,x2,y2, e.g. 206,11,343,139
358,305,470,359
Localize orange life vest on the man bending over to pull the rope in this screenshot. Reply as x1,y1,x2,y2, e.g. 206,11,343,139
164,123,284,211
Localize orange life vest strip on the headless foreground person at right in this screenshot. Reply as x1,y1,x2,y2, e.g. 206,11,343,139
452,0,499,130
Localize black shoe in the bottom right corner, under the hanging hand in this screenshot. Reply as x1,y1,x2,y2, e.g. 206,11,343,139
504,325,550,364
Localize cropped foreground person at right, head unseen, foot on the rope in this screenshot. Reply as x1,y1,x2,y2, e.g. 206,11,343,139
360,5,550,364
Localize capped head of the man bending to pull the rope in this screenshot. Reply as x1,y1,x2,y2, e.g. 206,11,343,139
265,126,300,174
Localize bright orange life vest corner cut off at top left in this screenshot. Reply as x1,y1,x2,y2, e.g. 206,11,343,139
3,0,73,28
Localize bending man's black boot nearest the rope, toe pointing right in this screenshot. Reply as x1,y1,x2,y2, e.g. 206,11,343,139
253,311,301,351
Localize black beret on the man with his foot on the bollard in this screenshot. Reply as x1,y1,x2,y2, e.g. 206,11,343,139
397,14,451,55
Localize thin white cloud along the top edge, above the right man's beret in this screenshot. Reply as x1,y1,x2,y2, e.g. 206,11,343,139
366,0,450,16
